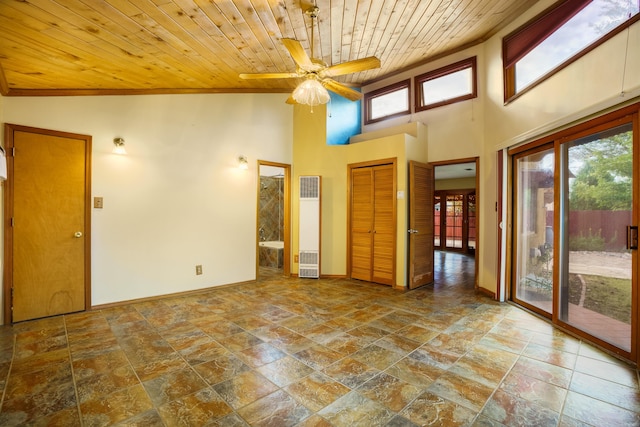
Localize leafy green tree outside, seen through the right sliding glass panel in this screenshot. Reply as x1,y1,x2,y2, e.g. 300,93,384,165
569,130,633,210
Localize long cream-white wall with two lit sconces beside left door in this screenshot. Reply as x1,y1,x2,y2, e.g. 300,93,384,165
0,94,293,305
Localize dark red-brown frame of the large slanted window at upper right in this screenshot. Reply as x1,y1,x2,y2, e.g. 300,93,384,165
502,0,640,105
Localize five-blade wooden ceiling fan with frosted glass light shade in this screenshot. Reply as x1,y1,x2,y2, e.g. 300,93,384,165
240,6,380,106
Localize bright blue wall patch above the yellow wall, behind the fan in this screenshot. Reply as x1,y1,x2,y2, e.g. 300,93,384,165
327,89,362,145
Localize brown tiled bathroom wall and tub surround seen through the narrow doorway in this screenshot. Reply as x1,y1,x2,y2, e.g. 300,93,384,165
258,176,284,268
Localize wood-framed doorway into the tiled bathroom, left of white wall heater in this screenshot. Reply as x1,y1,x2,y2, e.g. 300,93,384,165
256,160,291,280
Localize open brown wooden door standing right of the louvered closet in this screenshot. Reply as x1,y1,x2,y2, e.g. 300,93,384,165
408,161,434,289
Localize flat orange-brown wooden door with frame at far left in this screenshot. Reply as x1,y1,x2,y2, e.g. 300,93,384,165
4,124,91,323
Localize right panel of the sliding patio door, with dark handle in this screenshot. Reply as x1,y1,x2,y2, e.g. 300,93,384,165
558,123,634,351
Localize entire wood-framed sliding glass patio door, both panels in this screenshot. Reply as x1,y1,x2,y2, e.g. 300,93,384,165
511,106,640,361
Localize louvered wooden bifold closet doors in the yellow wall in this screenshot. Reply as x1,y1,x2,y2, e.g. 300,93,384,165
350,164,396,285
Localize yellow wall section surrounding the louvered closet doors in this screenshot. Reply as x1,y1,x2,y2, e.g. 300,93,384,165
291,105,427,287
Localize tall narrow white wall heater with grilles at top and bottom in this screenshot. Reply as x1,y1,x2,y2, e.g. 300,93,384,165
298,176,320,279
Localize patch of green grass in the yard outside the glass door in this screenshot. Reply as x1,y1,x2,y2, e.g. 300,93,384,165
569,274,631,324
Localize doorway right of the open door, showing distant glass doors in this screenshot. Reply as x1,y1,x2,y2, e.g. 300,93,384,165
431,157,479,288
